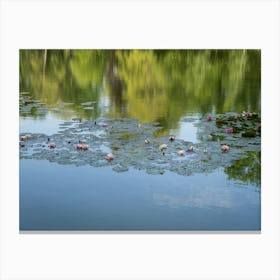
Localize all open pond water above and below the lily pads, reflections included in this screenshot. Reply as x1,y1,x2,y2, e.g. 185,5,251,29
19,50,261,230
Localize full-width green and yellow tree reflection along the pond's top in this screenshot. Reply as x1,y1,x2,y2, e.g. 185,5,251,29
20,50,261,126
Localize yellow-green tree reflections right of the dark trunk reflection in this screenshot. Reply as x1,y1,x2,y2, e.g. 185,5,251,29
113,50,260,136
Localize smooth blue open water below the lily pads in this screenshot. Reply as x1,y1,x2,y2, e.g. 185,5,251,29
20,160,261,230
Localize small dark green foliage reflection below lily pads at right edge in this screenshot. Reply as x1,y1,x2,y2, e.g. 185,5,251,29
225,152,261,186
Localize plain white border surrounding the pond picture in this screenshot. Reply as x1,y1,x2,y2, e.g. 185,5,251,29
0,0,280,280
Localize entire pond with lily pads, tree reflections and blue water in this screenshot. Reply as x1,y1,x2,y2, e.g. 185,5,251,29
19,50,261,231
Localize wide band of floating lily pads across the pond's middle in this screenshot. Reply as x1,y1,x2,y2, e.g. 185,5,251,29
20,114,261,175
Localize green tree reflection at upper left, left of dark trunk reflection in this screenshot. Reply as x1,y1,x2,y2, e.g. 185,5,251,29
20,50,108,118
